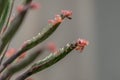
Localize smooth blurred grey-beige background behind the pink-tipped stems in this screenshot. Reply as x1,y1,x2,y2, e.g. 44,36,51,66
10,0,120,80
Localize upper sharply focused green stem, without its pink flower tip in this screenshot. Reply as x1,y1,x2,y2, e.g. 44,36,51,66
0,12,70,72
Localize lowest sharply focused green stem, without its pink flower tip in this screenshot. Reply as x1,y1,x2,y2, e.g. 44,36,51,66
15,43,77,80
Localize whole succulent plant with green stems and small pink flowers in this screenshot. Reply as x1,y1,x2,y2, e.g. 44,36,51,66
0,0,88,80
